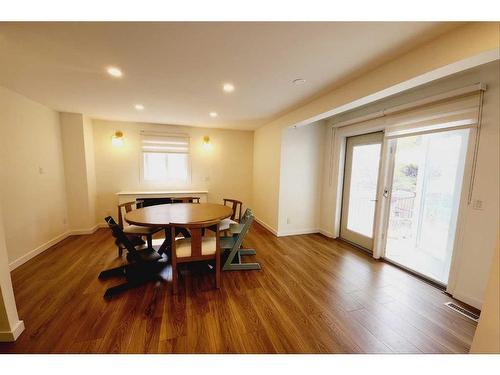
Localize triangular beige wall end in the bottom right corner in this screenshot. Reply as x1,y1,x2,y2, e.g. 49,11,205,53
470,237,500,353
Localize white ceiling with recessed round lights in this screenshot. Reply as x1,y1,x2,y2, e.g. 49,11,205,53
0,22,457,129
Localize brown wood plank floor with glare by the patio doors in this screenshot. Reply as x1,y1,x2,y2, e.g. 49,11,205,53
0,224,475,353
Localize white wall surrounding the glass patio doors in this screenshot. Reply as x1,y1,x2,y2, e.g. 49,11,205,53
321,61,500,308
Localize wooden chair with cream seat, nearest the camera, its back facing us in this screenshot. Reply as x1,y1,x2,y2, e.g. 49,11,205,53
171,220,221,294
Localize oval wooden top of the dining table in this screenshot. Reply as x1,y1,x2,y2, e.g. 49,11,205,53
125,203,233,227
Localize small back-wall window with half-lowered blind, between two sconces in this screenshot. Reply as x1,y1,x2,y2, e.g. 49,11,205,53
141,132,189,185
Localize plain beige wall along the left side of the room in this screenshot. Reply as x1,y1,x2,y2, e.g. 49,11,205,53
0,87,67,263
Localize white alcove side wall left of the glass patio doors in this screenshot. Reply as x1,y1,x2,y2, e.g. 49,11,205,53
278,121,325,236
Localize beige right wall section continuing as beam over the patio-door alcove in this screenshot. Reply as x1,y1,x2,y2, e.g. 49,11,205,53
253,23,499,232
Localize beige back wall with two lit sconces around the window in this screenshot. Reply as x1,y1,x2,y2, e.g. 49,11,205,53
93,120,253,221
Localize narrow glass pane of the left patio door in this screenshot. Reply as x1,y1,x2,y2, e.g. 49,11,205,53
347,143,381,238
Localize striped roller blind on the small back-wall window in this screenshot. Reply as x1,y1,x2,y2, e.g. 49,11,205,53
141,131,189,154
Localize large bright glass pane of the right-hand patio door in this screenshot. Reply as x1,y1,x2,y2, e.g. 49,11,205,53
385,129,469,284
